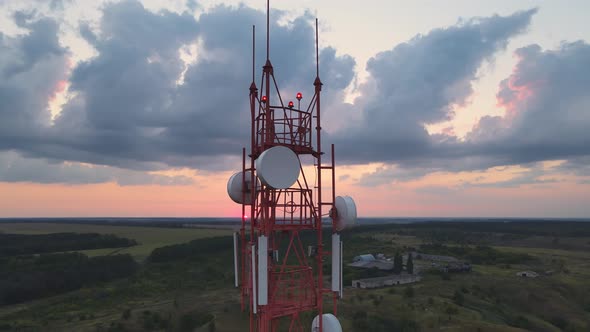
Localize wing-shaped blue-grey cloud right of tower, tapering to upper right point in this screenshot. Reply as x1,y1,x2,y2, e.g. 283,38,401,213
333,10,536,166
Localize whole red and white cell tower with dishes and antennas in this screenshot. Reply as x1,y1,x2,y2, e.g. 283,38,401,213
227,0,357,332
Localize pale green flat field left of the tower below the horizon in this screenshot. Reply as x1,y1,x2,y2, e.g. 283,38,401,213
0,222,231,261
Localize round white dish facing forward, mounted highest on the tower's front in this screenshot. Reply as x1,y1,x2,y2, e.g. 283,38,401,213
256,146,301,189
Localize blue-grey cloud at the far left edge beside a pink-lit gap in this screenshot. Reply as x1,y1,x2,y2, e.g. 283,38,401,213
0,12,68,142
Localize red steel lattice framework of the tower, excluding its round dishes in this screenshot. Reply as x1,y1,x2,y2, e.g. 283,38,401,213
234,1,342,332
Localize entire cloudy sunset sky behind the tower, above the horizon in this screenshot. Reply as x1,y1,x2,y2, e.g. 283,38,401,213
0,0,590,217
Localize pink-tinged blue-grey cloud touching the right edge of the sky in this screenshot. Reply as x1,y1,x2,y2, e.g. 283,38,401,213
467,41,590,164
